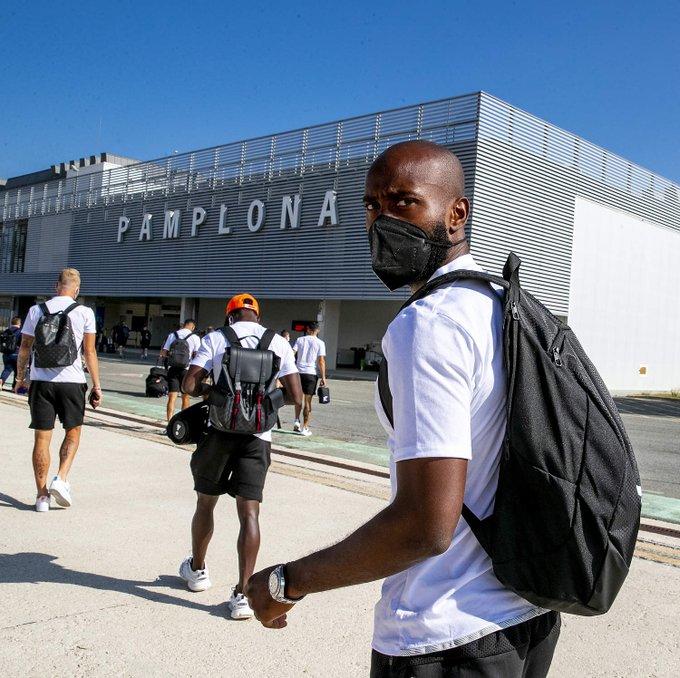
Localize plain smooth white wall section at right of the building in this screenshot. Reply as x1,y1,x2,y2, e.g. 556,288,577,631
569,198,680,391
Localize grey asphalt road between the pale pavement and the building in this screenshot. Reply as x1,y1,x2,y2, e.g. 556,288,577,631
91,356,680,499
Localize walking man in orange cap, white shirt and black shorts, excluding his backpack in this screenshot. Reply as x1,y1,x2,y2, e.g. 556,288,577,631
179,294,302,619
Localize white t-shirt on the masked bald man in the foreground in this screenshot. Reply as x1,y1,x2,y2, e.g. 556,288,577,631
373,254,544,655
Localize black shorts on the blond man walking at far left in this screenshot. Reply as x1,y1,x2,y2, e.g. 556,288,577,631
28,381,87,431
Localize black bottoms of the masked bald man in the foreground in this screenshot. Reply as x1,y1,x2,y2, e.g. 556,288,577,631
371,612,560,678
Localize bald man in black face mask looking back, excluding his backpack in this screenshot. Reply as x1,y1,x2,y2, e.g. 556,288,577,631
247,141,559,678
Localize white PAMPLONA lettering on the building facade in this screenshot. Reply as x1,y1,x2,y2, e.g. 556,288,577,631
117,191,338,243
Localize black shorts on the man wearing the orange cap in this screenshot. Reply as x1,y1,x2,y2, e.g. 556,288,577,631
191,429,271,501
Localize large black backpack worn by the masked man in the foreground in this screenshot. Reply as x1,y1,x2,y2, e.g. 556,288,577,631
378,253,642,615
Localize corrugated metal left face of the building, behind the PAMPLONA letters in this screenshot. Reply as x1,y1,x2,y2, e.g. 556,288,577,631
0,94,478,299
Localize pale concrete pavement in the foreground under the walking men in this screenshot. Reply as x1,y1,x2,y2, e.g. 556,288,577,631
0,401,680,678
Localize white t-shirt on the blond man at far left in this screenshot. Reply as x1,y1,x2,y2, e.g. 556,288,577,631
21,296,97,384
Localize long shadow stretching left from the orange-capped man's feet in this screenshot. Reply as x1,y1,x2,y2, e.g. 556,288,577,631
0,552,239,621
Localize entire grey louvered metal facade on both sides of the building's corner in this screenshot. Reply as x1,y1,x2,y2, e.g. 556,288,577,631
0,93,680,315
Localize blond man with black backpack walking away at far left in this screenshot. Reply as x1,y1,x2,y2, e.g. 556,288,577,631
14,268,102,512
